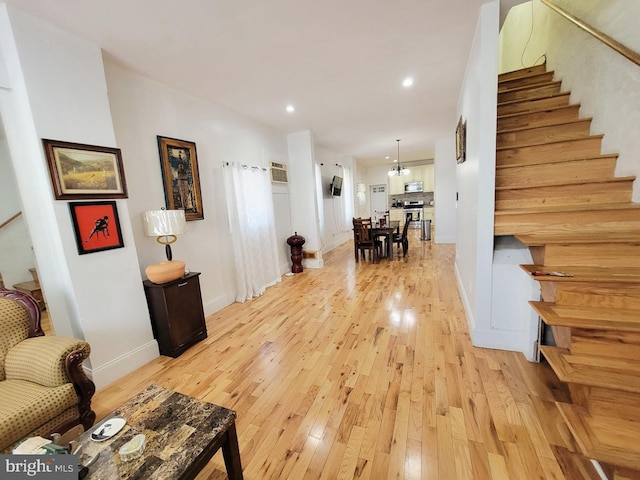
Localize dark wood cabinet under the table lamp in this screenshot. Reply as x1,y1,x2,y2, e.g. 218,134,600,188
144,272,207,358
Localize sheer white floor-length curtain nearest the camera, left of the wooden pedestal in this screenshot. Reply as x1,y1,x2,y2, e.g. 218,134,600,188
222,162,280,302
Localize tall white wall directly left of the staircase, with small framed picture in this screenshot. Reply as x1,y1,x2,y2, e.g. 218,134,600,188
452,0,499,346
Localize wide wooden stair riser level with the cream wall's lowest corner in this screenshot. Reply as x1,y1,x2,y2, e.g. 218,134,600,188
495,180,633,211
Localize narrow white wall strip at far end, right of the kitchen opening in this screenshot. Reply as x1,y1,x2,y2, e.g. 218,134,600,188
433,137,457,243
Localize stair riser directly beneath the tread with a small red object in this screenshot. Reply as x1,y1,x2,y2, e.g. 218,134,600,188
554,282,640,311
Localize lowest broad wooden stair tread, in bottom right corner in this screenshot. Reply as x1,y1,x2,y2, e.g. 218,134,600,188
556,402,640,470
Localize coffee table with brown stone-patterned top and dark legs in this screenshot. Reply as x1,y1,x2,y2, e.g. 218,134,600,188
78,385,243,480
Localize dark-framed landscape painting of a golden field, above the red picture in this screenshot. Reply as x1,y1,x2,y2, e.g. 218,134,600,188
42,139,128,200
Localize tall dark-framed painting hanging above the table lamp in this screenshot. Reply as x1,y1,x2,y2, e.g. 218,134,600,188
158,135,204,221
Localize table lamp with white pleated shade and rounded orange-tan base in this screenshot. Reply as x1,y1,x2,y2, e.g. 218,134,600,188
142,209,187,283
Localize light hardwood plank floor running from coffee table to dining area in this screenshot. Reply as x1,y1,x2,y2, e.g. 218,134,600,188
93,231,596,480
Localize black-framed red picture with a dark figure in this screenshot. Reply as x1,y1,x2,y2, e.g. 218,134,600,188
69,201,124,255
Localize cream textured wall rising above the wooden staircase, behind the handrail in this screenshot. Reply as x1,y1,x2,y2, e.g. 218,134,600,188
500,0,640,202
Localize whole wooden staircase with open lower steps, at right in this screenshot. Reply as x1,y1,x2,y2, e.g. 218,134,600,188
495,65,640,479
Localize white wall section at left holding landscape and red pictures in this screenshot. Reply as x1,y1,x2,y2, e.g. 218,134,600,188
0,5,158,386
